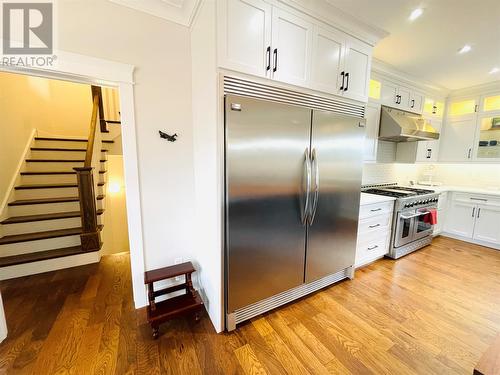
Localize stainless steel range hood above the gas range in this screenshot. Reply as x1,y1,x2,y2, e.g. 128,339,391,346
378,106,439,142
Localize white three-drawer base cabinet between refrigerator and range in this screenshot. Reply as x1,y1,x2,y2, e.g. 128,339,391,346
355,201,394,267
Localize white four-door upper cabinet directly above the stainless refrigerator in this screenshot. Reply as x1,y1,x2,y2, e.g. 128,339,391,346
217,0,372,102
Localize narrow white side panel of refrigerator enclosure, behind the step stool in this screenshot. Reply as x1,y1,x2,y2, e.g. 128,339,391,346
191,1,224,331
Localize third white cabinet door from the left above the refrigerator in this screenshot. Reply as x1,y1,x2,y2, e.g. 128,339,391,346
311,27,345,95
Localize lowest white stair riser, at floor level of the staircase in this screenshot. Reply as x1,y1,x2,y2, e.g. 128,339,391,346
0,251,100,280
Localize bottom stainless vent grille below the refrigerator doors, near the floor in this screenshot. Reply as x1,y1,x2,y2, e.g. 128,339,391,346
234,267,351,324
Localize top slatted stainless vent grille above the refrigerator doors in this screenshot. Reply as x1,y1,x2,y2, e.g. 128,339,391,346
224,76,365,118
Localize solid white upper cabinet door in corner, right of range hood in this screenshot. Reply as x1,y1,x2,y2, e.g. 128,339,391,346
439,116,476,161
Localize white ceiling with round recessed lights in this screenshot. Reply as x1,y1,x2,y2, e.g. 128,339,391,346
327,0,500,90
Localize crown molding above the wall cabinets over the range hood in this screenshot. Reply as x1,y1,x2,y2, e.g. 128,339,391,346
372,58,450,98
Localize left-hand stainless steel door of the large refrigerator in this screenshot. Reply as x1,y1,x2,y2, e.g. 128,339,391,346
225,95,311,313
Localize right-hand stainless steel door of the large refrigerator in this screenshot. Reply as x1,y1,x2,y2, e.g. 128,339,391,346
305,111,364,282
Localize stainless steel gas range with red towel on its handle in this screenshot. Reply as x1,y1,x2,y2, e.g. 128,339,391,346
363,184,439,259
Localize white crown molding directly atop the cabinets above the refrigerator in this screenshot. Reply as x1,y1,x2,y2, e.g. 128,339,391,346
275,0,389,46
